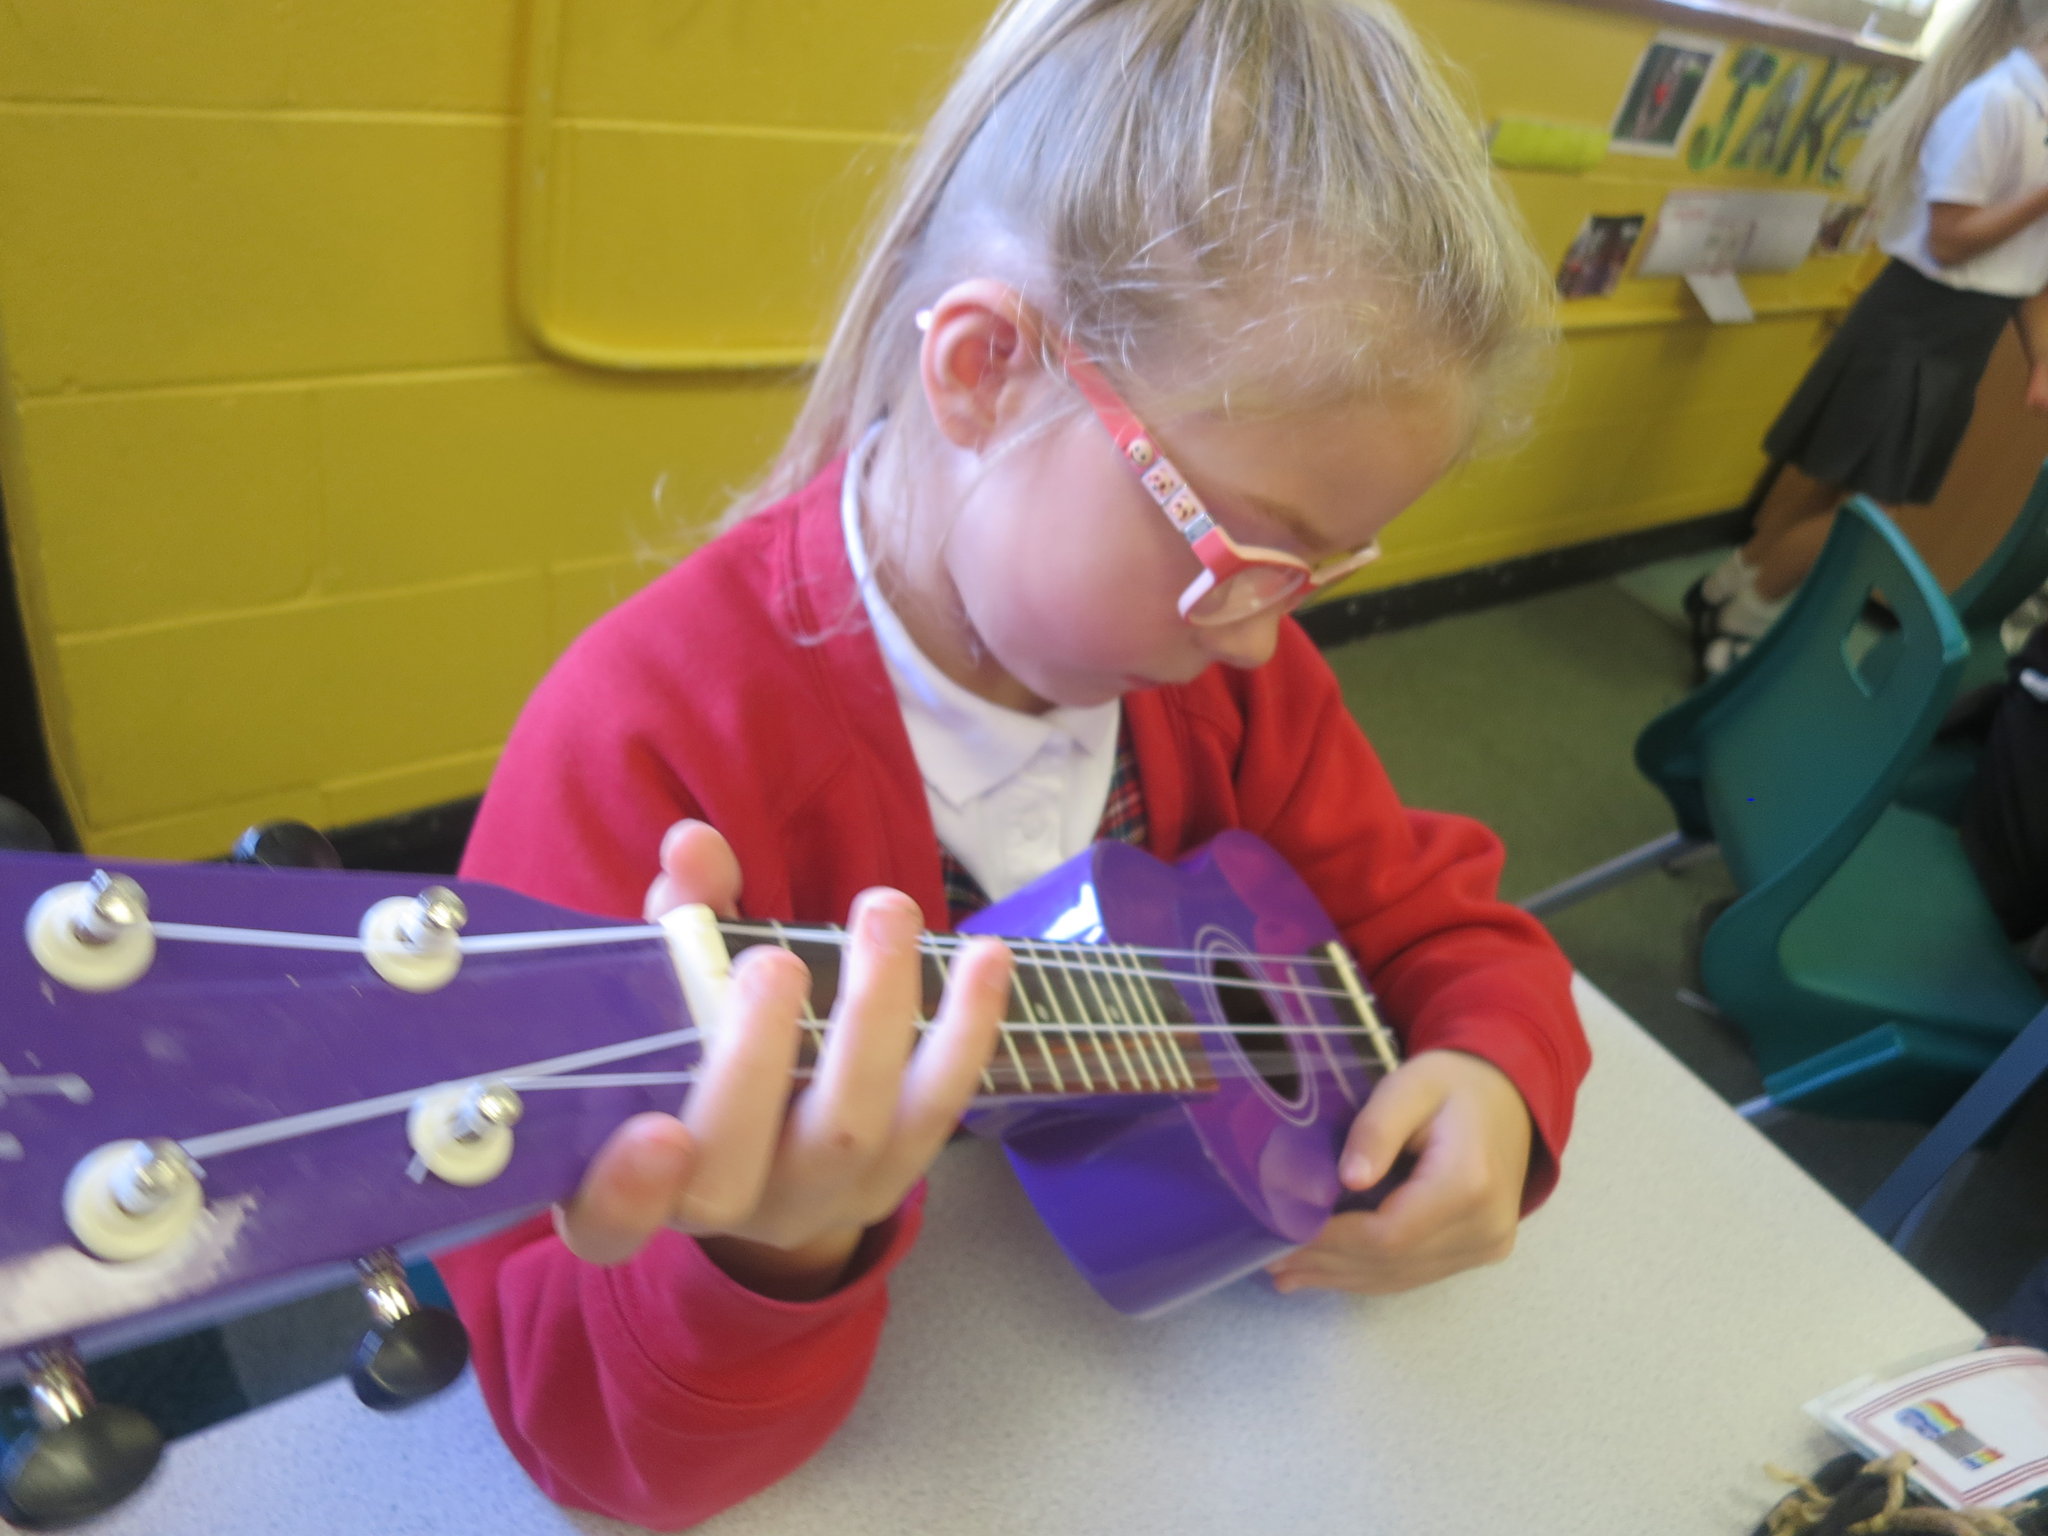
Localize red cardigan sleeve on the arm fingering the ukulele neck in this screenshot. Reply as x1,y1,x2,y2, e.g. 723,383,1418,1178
440,618,920,1530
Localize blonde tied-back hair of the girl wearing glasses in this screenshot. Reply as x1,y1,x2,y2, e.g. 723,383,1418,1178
733,0,1550,516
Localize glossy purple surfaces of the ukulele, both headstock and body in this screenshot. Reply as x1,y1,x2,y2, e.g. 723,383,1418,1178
0,834,1372,1372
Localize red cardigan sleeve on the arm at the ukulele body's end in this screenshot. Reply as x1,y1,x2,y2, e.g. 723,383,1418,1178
1235,623,1591,1210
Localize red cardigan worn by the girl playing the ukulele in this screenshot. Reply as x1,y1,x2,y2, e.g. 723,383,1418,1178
442,456,1587,1530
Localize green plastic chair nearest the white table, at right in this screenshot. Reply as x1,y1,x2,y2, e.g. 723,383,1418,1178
1636,498,2048,1118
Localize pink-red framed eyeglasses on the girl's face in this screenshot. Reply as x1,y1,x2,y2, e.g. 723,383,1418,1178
1065,350,1380,625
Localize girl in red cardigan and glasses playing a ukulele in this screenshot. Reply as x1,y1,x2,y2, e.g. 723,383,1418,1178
446,0,1587,1526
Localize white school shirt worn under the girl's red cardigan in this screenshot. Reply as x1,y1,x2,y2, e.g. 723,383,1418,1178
840,426,1122,901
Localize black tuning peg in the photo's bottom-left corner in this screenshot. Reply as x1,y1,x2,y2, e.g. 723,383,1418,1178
0,1343,164,1530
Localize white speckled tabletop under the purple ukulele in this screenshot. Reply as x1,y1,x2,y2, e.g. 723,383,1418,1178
92,983,1976,1536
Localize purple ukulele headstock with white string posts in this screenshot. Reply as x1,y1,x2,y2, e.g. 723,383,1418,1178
0,854,696,1352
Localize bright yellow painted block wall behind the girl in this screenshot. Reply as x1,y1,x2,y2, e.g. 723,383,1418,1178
0,0,1900,856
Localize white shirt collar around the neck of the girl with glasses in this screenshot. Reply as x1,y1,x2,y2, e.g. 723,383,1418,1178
840,422,1122,807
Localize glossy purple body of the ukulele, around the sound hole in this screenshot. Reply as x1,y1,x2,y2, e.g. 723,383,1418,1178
963,831,1374,1317
